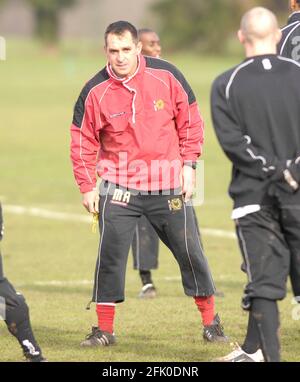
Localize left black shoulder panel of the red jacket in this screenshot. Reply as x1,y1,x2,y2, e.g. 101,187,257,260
72,68,109,128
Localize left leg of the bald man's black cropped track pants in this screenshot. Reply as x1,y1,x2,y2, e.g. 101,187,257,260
236,206,290,309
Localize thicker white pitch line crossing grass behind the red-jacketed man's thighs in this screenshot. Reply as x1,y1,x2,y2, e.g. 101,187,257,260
3,204,236,239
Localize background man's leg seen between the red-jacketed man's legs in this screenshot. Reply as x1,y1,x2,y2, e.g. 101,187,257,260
132,216,159,298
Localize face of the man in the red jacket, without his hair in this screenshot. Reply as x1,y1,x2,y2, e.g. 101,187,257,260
104,31,141,78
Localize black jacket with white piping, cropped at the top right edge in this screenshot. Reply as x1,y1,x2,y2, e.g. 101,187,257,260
277,12,300,62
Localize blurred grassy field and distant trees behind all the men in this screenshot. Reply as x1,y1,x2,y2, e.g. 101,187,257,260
0,0,300,361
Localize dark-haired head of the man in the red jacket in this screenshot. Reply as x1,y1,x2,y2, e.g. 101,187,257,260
104,21,142,78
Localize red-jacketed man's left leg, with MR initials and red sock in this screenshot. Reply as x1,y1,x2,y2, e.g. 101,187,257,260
81,183,141,346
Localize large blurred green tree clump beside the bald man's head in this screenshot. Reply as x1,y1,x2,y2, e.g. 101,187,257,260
152,0,289,53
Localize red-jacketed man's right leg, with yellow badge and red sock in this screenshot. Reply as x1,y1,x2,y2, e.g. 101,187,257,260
146,195,227,341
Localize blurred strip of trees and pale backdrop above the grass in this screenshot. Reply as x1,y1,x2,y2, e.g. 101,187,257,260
0,0,288,53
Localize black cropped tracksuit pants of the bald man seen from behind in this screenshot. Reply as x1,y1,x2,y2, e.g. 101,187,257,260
236,201,300,309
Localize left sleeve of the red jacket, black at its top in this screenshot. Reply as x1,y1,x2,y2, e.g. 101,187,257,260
71,89,100,193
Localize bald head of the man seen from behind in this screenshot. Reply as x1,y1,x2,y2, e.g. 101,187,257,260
238,7,281,57
